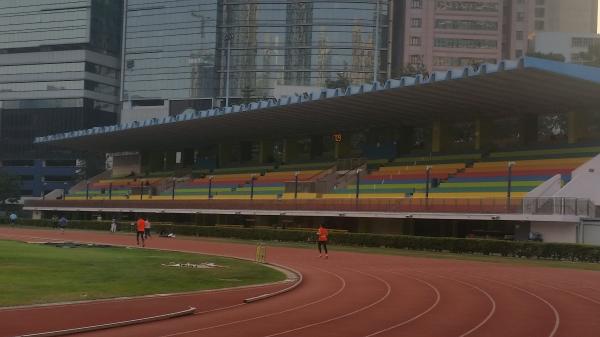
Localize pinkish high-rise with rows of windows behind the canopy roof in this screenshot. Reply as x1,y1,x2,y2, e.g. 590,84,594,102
393,0,530,71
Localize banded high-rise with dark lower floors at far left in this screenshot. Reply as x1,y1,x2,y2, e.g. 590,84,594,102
0,0,122,196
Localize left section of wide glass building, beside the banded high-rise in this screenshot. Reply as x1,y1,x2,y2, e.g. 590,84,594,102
123,0,218,100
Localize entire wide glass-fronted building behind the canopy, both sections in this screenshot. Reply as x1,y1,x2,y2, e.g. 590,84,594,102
123,0,389,103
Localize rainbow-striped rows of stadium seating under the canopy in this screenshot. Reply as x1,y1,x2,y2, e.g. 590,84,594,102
67,146,600,200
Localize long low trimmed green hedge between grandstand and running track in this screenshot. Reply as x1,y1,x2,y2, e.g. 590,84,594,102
9,220,600,263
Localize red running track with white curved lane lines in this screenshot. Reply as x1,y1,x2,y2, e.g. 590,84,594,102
0,228,600,337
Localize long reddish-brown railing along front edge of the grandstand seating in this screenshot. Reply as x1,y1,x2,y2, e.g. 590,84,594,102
26,198,597,217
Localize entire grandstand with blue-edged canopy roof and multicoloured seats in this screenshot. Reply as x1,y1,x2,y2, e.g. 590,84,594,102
26,58,600,244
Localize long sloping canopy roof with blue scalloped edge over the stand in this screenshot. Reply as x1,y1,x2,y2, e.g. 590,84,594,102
35,58,600,152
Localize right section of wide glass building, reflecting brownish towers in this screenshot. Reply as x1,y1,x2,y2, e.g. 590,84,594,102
219,0,389,97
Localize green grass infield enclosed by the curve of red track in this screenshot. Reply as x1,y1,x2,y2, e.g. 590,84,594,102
0,241,285,307
